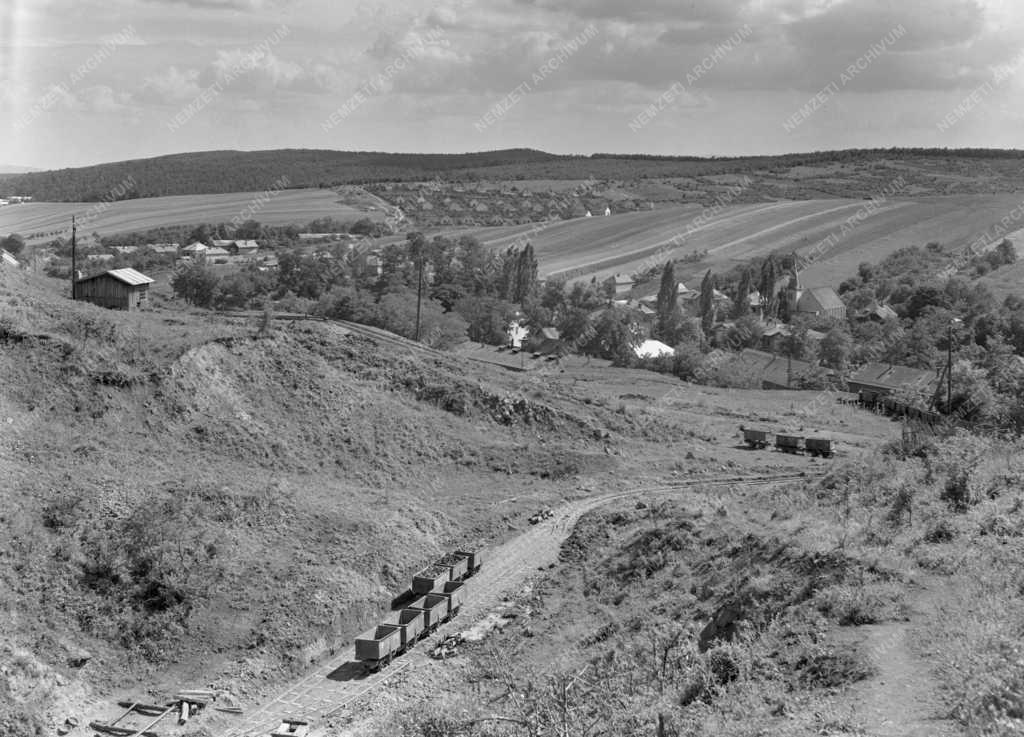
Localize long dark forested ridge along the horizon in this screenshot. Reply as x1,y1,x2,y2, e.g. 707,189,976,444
6,148,1024,202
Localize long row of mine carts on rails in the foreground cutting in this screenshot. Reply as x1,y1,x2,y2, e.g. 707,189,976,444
355,550,482,671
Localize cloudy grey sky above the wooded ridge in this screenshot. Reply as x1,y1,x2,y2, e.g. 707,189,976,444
0,0,1024,169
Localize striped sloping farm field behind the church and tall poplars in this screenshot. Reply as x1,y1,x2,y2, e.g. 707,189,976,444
430,193,1020,287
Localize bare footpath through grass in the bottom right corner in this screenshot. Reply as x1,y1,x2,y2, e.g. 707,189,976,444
850,586,963,737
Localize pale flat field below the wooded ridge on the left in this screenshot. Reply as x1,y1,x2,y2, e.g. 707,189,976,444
0,189,384,241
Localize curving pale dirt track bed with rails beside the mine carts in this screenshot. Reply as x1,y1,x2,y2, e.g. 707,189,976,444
207,473,803,737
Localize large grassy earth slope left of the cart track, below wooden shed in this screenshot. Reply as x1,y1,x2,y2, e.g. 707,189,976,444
0,274,613,734
